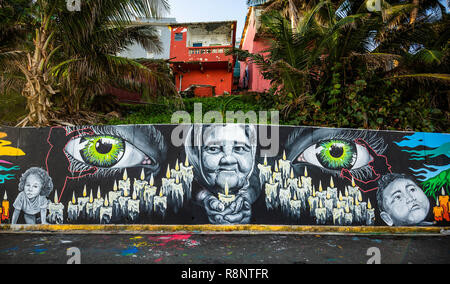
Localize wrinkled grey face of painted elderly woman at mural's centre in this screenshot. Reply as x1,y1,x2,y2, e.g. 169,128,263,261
202,125,254,192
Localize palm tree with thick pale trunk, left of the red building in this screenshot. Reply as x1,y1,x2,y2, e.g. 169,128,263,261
1,0,178,126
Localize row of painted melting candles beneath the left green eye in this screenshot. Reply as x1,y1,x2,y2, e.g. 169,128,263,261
47,157,194,224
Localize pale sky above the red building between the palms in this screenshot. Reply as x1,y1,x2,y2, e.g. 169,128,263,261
167,0,247,39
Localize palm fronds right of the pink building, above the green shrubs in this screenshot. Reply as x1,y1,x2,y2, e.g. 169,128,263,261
234,1,450,123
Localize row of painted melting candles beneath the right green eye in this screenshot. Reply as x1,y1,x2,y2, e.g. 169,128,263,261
258,154,375,226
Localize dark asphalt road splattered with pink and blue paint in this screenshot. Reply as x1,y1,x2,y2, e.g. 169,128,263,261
0,233,450,265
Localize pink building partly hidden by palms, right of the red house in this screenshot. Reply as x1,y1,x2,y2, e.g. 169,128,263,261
239,6,270,92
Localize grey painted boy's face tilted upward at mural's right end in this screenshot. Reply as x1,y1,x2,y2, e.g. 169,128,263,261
381,178,430,226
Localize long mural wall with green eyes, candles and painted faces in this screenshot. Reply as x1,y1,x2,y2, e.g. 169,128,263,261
0,124,450,226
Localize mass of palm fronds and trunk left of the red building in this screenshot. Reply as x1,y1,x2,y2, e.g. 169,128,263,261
0,0,177,126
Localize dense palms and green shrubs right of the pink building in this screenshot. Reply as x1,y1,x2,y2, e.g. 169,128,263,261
233,0,450,132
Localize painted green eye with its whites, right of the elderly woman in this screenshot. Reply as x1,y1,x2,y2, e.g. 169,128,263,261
296,139,372,171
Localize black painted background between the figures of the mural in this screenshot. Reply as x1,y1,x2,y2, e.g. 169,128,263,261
0,125,450,225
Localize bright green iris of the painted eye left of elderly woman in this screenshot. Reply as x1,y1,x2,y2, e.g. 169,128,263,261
80,136,125,167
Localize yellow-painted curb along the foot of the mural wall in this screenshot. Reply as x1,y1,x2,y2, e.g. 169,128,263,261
0,224,450,236
